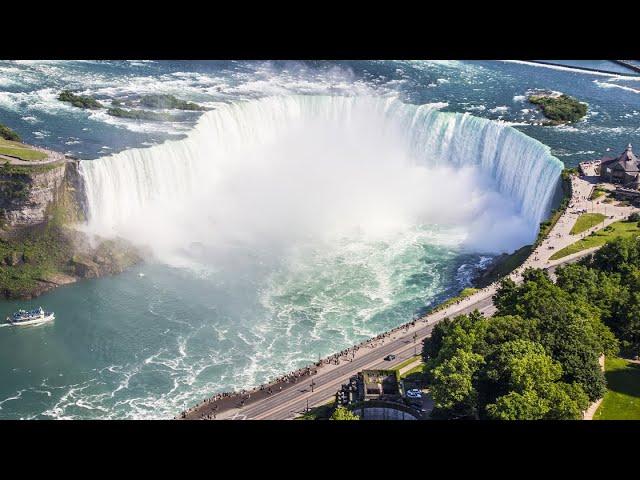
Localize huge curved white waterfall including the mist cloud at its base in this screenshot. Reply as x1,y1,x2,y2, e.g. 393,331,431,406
81,96,563,266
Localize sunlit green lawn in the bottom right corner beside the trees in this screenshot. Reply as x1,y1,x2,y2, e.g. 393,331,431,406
593,358,640,420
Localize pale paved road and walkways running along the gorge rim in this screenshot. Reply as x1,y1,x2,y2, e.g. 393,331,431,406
187,172,637,420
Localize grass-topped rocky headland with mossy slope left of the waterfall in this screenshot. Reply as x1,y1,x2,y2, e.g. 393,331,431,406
0,122,141,299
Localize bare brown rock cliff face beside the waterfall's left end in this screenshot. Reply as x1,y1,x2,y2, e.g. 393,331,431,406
0,161,83,230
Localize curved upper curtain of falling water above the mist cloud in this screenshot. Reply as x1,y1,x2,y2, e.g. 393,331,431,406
80,95,563,240
